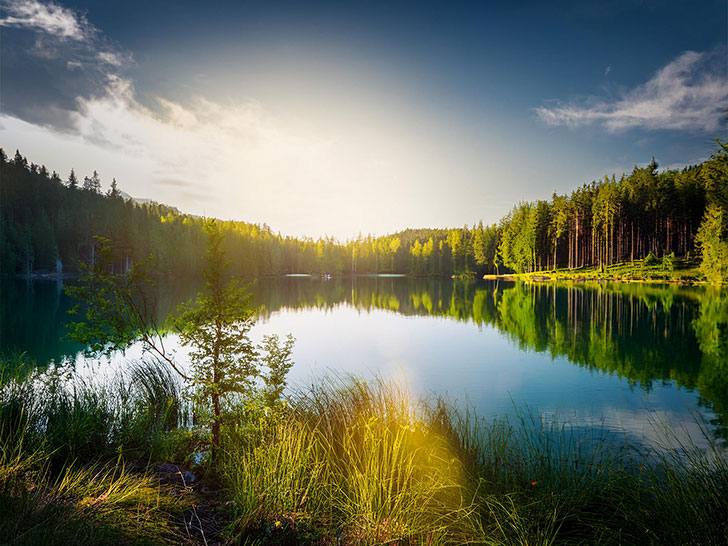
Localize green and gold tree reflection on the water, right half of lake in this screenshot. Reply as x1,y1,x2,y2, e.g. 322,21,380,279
257,277,728,435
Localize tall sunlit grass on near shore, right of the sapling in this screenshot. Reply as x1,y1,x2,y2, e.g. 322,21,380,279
223,378,728,546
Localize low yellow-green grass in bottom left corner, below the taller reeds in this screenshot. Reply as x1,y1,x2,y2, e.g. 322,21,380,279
0,440,192,545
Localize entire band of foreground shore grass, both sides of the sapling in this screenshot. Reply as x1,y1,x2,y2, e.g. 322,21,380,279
0,360,728,545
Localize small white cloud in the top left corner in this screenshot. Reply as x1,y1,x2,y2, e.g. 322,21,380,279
0,0,90,41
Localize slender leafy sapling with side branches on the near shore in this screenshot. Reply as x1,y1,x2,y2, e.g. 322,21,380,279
67,222,294,460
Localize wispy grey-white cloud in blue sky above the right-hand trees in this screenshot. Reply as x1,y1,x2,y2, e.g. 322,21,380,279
535,49,728,133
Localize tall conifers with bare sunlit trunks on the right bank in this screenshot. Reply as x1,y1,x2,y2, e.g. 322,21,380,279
497,143,728,276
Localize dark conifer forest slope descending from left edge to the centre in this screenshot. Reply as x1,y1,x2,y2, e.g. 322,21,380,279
0,151,347,278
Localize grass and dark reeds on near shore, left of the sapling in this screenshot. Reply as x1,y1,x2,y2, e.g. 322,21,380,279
0,354,192,545
